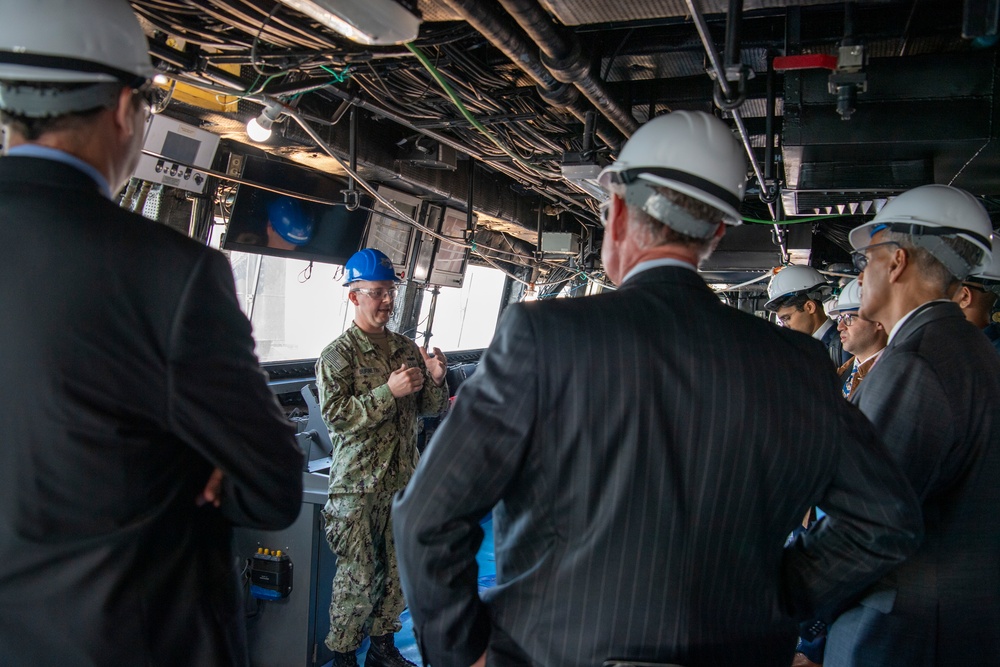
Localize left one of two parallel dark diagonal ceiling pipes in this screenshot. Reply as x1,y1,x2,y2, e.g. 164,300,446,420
443,0,621,149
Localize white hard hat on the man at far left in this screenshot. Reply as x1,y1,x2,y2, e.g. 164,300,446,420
0,0,156,115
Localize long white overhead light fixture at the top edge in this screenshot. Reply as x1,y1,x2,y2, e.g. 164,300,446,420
278,0,420,44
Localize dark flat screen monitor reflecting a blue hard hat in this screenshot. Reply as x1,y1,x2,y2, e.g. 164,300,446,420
222,156,371,264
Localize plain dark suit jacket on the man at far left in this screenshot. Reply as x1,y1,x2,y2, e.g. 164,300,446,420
0,157,302,667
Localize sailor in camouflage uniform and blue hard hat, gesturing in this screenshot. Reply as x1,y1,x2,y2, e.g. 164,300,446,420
316,249,448,667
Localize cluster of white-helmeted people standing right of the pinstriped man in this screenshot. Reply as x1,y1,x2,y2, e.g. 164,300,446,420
765,185,1000,664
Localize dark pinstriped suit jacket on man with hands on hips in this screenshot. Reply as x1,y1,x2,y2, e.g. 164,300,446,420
394,267,919,667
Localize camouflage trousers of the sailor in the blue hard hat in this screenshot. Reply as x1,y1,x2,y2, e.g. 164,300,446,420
323,492,406,653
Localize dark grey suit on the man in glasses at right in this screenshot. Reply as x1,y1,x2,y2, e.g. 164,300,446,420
825,302,1000,667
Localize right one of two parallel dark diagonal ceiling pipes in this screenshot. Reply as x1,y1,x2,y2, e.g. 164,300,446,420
496,0,639,138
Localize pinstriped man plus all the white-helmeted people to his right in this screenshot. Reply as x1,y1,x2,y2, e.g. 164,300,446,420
394,112,1000,666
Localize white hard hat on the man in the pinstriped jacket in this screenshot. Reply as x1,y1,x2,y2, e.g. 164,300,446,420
597,111,747,225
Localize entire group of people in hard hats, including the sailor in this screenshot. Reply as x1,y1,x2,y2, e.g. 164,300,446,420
0,0,1000,667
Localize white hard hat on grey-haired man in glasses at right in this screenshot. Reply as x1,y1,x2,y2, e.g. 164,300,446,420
850,185,993,280
